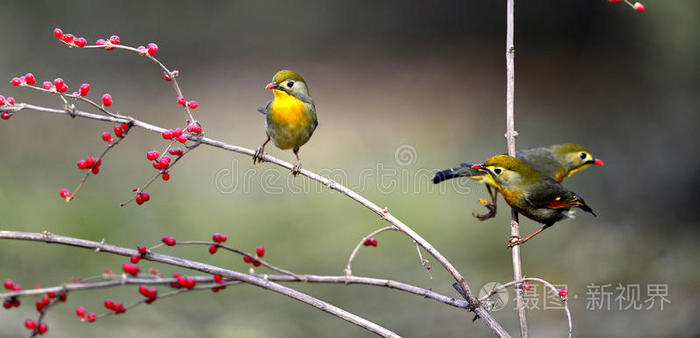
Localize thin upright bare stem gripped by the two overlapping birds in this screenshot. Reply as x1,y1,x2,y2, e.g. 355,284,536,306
506,0,527,338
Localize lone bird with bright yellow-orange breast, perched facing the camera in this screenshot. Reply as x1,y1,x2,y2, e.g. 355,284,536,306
253,70,318,176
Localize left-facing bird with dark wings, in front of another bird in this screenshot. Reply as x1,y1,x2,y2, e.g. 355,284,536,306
470,155,596,247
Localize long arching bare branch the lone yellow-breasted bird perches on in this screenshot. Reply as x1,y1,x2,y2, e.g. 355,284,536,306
2,103,510,337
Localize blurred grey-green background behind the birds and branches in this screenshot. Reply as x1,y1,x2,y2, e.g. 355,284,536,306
0,0,700,337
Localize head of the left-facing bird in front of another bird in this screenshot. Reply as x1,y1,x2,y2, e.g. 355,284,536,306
472,155,542,190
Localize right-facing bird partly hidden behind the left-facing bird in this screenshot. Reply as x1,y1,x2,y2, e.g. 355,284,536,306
433,143,604,221
